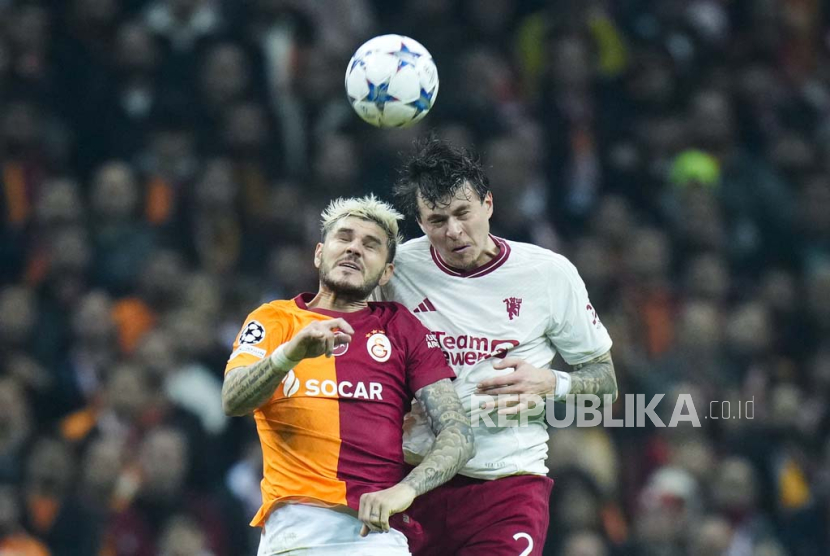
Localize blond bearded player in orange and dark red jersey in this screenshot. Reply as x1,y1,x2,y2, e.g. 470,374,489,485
222,196,474,556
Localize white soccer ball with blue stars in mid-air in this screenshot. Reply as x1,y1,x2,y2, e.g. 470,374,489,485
346,35,438,127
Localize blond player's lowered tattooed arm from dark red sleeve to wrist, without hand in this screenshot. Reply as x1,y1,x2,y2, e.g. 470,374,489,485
402,379,475,496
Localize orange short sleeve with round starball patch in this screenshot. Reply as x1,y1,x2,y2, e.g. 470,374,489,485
225,304,286,374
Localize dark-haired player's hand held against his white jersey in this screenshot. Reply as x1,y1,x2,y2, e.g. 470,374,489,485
476,357,556,415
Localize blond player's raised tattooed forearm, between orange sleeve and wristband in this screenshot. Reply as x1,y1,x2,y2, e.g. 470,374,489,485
222,357,288,417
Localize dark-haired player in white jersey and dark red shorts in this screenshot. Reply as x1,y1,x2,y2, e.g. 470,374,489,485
380,138,617,556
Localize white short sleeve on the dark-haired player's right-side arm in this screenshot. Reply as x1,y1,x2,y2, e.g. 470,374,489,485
547,255,612,365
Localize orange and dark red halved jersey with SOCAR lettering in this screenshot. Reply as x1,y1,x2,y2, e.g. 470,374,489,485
225,294,455,526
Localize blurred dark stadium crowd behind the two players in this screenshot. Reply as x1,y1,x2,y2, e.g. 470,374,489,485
0,0,830,556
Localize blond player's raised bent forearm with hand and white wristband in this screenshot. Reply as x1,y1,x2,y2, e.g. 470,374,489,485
222,319,354,417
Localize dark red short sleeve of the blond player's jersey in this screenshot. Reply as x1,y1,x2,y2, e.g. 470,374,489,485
397,307,455,394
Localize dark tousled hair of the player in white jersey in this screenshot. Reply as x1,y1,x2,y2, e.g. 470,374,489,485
394,135,490,220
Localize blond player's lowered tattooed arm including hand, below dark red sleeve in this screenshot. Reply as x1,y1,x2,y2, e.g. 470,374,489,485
358,378,475,536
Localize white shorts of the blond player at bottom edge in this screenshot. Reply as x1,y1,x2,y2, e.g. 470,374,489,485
257,504,411,556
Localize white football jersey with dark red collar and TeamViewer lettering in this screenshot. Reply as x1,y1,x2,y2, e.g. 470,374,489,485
380,236,611,479
